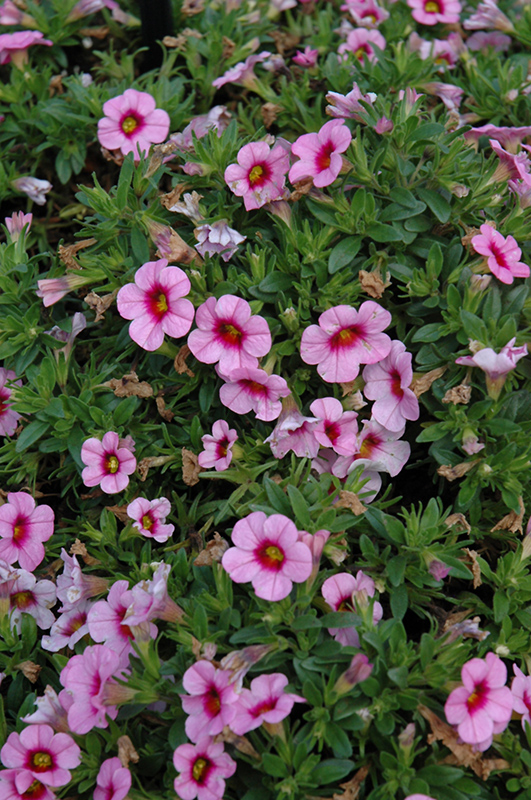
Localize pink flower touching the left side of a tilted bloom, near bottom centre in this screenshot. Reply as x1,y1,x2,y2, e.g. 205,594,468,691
181,660,238,742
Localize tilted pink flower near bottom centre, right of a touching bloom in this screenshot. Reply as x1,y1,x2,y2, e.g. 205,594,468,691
230,672,307,736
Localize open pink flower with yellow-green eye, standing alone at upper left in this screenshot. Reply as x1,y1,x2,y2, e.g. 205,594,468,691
98,89,170,161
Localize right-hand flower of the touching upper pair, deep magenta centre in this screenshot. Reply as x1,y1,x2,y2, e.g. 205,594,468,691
288,119,352,188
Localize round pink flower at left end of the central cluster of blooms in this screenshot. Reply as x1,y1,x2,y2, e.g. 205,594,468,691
116,258,194,351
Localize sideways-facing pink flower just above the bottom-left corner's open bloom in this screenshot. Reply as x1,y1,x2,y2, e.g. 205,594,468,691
59,644,129,733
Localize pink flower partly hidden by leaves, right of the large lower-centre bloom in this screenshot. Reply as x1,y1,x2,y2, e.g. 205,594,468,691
321,570,383,647
